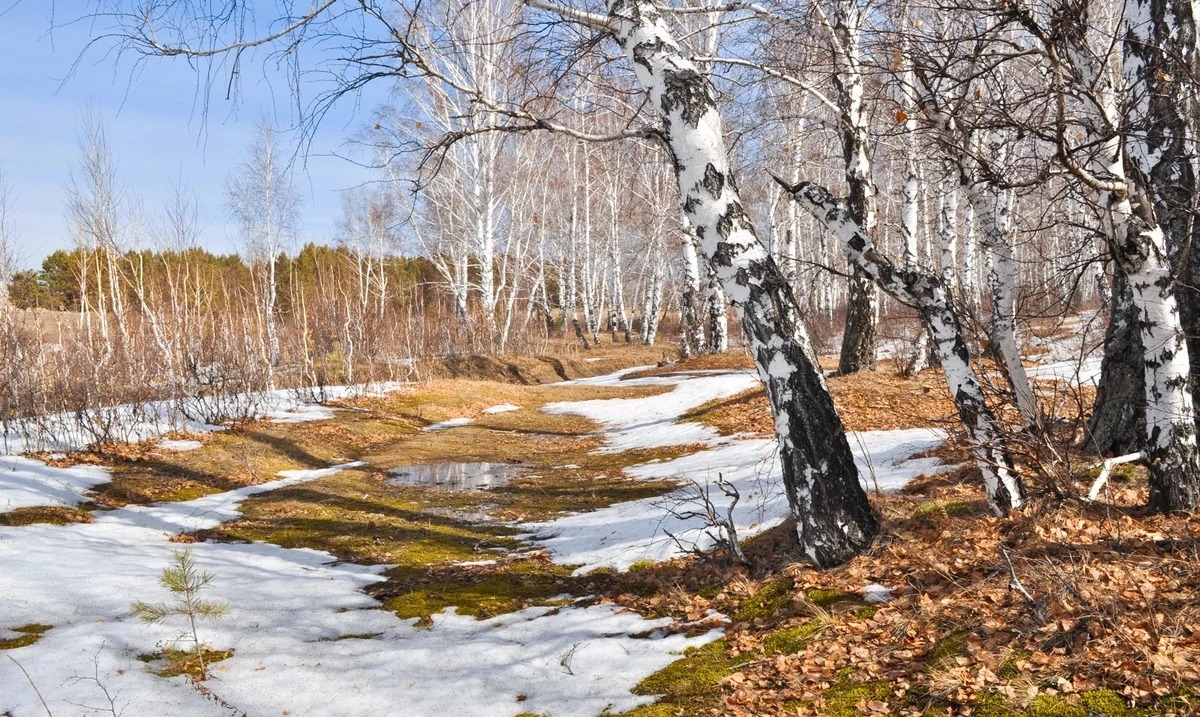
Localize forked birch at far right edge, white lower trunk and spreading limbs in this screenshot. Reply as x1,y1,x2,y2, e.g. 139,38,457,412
1016,0,1200,512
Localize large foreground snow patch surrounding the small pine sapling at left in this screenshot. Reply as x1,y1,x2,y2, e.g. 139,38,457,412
0,464,713,717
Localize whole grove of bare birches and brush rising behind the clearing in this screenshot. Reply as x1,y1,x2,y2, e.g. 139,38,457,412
0,0,1185,566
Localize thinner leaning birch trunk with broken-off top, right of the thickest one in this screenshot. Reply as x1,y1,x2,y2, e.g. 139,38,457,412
776,179,1025,516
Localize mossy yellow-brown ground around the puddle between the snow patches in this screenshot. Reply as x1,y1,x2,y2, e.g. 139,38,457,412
177,381,701,625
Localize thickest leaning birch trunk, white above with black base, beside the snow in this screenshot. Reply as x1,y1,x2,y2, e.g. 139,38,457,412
608,0,878,566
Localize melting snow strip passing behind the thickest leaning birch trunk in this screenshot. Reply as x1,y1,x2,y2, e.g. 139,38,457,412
527,372,953,573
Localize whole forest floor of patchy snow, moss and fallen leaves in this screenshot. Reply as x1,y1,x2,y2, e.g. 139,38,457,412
0,349,1200,717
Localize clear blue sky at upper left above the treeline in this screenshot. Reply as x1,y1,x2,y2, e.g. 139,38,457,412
0,0,389,266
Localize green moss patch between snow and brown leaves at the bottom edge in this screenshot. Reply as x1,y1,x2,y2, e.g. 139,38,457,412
628,640,745,717
